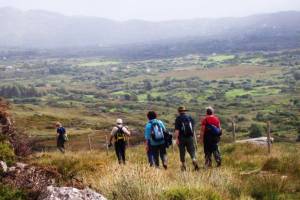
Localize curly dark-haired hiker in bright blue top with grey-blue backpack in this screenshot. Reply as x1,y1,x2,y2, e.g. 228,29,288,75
145,111,168,169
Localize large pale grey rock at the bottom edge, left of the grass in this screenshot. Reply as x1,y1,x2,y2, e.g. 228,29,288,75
38,186,106,200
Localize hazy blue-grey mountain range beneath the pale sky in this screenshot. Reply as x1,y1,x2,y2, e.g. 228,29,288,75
0,7,300,55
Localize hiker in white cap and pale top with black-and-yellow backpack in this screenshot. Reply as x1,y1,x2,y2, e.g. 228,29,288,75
108,119,130,165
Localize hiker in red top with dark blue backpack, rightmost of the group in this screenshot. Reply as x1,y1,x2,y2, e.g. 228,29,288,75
200,107,222,168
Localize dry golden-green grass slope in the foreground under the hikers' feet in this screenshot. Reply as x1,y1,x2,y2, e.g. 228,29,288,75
31,144,300,200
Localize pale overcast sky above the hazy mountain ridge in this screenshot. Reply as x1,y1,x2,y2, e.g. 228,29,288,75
0,0,300,21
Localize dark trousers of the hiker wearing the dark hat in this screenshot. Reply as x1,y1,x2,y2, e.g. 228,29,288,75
178,137,196,163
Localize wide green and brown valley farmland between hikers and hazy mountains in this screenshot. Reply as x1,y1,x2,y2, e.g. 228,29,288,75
0,50,300,150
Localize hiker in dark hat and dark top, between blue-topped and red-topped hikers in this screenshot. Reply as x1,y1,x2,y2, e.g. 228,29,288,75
175,106,199,171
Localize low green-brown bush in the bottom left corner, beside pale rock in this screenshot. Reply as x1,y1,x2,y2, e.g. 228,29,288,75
0,183,27,200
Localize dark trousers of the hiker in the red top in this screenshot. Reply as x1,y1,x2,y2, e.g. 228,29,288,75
203,134,221,167
